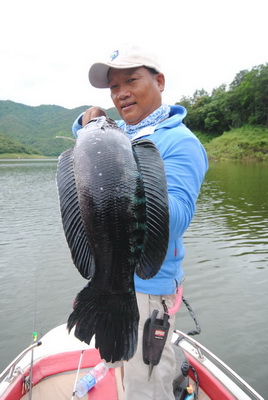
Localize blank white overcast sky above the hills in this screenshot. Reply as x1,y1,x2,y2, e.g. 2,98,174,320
0,0,268,108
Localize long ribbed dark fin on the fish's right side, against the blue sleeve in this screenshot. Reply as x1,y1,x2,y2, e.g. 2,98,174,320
132,139,169,279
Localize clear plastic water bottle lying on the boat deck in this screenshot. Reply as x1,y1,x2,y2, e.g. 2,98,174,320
75,362,109,398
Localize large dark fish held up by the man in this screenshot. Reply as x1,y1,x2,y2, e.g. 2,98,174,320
57,117,169,362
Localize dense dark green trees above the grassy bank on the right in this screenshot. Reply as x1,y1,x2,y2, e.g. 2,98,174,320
176,63,268,136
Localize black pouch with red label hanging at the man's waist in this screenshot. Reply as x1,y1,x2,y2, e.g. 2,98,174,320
142,310,170,366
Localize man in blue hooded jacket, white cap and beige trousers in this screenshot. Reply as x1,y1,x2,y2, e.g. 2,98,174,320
73,46,208,400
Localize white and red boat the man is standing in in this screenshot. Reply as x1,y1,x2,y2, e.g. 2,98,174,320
0,324,264,400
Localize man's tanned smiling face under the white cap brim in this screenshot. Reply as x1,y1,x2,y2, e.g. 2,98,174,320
108,67,165,125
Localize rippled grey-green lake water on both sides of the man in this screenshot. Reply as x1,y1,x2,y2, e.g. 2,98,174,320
0,160,268,397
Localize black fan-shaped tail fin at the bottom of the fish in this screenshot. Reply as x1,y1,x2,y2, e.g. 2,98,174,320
67,282,139,362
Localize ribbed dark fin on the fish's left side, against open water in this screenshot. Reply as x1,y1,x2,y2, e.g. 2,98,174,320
57,148,95,279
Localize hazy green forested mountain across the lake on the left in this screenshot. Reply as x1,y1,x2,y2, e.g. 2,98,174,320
0,101,119,156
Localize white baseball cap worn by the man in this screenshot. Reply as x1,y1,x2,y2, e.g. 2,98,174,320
88,46,161,88
